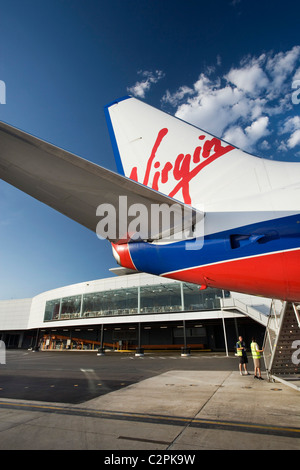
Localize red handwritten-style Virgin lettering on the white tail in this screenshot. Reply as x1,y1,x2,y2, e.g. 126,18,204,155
130,128,234,204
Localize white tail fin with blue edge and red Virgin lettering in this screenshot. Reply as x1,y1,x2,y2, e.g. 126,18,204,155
105,96,240,206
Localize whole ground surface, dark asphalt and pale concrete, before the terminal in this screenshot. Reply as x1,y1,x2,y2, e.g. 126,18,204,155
0,351,300,452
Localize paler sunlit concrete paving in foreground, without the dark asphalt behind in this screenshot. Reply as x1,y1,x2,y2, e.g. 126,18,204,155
0,364,300,452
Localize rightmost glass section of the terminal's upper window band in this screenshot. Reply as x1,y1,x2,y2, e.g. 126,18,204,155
183,283,222,311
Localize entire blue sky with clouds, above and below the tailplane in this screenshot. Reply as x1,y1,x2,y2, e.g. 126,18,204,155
0,0,300,299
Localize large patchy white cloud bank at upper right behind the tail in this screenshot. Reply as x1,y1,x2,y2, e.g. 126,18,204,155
162,46,300,152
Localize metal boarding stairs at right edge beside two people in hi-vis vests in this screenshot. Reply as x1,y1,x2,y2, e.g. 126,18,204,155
264,301,300,391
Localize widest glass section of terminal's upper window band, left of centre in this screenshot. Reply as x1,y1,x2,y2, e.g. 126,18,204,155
82,287,138,317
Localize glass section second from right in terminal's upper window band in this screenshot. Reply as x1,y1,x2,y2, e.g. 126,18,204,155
140,282,182,314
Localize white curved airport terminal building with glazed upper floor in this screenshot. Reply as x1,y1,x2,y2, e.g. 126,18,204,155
0,268,270,352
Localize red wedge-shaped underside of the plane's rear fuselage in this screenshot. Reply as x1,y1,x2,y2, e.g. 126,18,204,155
164,250,300,301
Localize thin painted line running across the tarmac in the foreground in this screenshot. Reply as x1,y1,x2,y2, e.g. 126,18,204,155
0,402,300,439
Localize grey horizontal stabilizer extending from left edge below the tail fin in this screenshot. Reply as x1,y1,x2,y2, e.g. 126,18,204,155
0,122,203,243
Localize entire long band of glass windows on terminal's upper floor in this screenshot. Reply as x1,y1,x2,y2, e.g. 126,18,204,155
44,282,230,321
